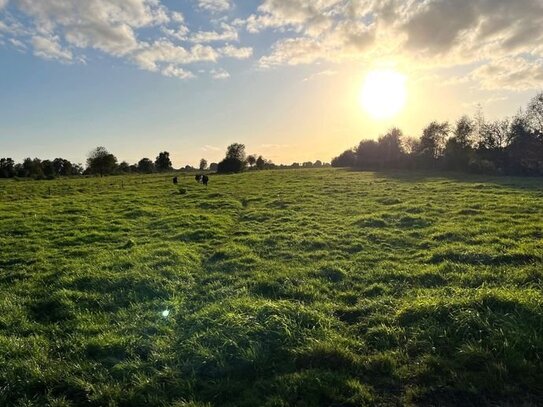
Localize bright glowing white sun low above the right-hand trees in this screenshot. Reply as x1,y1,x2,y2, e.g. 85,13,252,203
360,70,407,120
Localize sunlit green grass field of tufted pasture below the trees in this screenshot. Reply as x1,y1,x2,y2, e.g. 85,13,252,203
0,169,543,407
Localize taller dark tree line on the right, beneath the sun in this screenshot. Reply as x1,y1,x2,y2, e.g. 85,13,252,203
332,92,543,175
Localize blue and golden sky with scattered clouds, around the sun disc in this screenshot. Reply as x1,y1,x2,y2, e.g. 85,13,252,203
0,0,543,167
